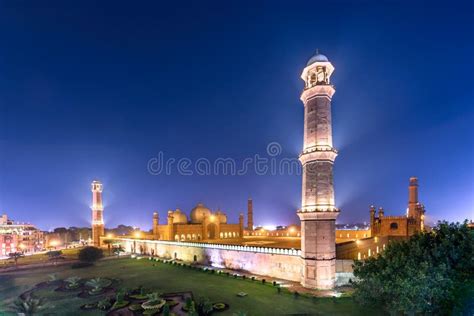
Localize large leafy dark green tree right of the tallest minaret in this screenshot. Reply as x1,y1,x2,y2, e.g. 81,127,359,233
354,222,474,314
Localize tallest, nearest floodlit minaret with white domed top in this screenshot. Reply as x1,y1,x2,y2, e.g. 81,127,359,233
298,52,339,289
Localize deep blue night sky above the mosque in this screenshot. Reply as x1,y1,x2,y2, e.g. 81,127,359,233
0,1,474,229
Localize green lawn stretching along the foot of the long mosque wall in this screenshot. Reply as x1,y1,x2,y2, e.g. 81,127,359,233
0,258,380,315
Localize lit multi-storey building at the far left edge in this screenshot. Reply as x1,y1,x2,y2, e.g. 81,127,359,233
0,214,44,257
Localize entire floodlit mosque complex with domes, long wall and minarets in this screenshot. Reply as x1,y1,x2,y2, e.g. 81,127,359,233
92,52,425,289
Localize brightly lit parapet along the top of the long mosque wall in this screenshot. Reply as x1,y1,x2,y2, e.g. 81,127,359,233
115,238,301,256
